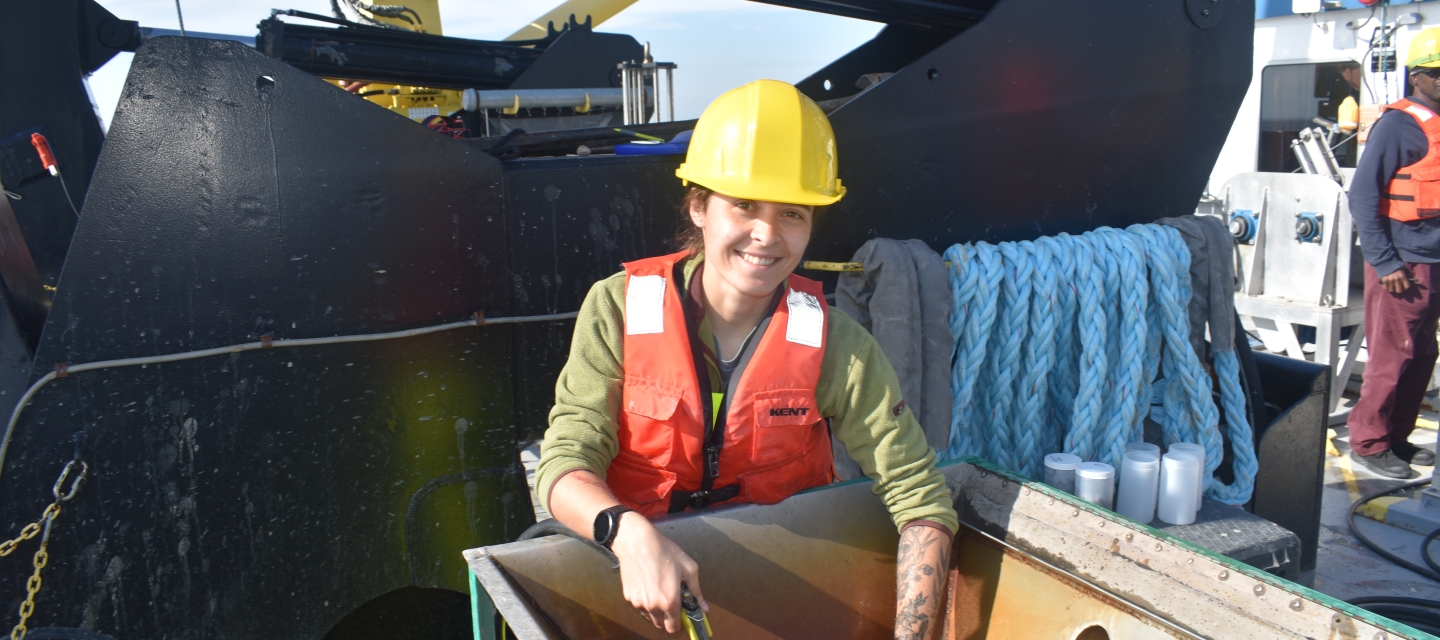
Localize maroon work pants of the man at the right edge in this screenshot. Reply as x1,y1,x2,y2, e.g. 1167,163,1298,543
1331,262,1440,455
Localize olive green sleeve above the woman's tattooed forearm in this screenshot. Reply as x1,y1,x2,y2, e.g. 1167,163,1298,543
815,308,959,533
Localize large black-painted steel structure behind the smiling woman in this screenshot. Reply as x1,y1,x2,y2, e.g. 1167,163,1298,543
0,0,1253,639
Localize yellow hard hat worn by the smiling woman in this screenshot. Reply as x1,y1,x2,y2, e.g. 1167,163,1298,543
675,79,845,206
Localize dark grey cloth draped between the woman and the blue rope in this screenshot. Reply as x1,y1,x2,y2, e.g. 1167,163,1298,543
832,238,955,480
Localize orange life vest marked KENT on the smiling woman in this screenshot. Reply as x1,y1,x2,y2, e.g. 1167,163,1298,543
605,252,834,516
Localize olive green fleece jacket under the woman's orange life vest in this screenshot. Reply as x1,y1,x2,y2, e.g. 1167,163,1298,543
536,258,959,533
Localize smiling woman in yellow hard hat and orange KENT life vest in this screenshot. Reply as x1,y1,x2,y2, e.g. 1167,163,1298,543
536,81,958,639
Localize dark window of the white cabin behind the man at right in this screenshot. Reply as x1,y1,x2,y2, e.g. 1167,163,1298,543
1256,62,1361,173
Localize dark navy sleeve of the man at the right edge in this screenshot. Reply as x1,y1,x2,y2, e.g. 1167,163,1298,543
1349,111,1424,277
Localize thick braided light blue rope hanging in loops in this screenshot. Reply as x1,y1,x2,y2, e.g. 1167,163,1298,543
945,225,1259,505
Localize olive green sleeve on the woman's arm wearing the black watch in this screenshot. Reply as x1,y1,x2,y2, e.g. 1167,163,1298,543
536,274,625,509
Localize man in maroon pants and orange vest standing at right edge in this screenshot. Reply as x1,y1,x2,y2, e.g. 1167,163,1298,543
1349,29,1440,479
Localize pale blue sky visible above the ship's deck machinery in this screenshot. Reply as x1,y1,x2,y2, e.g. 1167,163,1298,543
89,0,880,125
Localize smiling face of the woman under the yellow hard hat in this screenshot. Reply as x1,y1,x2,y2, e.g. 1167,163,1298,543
690,193,815,297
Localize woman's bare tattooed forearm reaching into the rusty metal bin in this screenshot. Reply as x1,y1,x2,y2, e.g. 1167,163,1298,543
896,526,952,640
